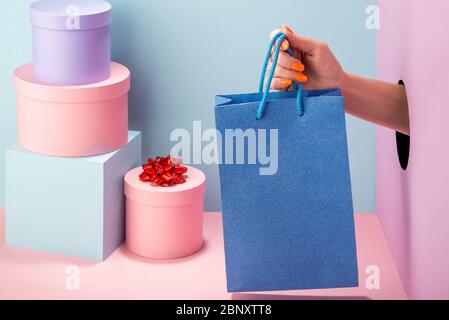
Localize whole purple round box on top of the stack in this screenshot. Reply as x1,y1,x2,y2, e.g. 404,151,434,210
30,0,112,86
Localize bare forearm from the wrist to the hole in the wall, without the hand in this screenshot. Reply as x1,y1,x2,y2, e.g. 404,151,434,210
339,73,410,135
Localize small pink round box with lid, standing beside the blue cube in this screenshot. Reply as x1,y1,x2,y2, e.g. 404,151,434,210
125,167,206,259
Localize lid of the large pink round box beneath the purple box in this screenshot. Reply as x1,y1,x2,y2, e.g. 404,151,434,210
14,62,131,103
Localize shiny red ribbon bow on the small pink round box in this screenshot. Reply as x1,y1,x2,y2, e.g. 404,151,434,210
139,155,187,187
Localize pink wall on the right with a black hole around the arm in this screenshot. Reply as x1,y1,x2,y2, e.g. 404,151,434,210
377,0,449,299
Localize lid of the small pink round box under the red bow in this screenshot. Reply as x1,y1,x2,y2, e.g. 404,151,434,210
125,166,206,206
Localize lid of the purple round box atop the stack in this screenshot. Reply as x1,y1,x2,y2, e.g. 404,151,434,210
30,0,112,30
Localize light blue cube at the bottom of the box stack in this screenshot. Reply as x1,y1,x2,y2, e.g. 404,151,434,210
6,131,142,261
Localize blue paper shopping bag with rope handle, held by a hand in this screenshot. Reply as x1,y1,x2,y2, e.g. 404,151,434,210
215,34,358,292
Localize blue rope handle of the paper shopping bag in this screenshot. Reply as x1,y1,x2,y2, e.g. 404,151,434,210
256,32,304,120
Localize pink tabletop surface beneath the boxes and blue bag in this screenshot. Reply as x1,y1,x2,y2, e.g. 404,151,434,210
0,209,406,300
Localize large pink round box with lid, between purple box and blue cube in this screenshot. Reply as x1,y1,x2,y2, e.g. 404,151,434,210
14,62,130,157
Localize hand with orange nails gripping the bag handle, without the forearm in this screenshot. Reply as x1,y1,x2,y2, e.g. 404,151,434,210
269,26,345,91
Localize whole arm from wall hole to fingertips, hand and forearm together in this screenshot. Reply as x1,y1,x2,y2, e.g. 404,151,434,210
270,26,410,134
